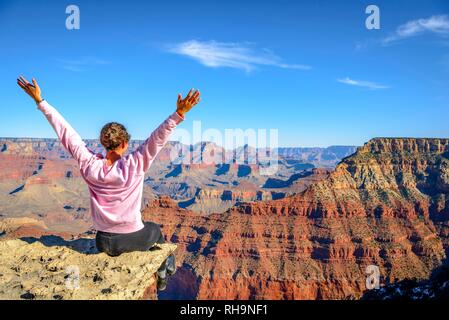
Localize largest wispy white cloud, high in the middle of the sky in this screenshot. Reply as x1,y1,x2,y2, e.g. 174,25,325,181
167,40,311,72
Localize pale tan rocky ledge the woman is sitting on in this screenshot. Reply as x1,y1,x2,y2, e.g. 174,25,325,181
0,240,176,300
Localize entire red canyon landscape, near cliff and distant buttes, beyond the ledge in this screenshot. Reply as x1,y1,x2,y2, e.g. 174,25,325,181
0,138,449,299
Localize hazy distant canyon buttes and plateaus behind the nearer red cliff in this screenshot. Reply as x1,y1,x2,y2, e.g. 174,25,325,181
0,138,355,228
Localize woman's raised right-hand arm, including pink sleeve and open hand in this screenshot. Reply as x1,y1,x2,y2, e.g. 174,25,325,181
130,89,201,172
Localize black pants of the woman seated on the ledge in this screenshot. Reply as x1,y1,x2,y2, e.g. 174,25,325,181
95,222,165,257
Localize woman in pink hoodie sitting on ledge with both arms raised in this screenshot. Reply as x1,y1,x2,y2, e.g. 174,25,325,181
17,77,200,290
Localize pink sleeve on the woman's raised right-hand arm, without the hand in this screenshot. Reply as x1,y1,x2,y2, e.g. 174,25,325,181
129,112,184,172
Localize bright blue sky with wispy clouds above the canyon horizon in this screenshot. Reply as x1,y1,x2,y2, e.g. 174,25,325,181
0,0,449,146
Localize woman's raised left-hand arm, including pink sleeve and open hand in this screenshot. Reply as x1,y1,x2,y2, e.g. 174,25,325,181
17,77,93,166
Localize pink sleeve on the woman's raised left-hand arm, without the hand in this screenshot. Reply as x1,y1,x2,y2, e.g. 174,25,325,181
37,100,93,167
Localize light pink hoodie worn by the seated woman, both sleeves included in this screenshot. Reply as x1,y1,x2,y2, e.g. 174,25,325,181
38,101,184,233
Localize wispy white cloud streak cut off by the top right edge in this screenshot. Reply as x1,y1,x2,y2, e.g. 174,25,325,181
382,15,449,44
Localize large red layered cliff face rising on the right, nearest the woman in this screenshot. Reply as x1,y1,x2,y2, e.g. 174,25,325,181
145,138,449,299
